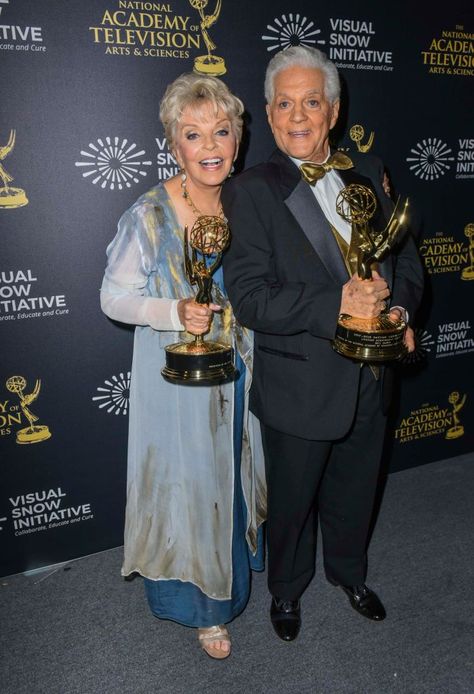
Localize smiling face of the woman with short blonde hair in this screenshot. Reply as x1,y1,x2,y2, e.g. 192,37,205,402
174,102,238,188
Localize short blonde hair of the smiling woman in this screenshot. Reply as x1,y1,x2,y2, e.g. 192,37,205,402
160,72,244,150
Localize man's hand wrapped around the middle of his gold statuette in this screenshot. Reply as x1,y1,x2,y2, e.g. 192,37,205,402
339,270,390,318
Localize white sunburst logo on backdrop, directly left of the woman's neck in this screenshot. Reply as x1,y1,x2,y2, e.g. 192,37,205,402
76,137,151,190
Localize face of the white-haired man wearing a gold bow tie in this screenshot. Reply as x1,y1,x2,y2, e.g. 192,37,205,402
267,65,339,164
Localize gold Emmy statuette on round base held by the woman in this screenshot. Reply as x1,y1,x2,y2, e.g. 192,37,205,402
161,215,236,386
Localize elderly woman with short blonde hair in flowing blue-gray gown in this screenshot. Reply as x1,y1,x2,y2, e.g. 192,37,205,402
101,74,265,658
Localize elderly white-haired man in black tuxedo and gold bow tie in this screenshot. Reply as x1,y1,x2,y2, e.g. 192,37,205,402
223,46,422,641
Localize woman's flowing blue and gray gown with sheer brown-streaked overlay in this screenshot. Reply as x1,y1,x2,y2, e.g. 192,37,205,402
101,184,265,627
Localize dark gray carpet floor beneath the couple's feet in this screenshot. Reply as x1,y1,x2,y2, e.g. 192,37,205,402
0,454,474,694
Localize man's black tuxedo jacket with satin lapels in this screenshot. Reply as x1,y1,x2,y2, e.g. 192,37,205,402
222,151,423,440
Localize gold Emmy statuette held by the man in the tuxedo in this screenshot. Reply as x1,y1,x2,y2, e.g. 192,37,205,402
333,183,408,363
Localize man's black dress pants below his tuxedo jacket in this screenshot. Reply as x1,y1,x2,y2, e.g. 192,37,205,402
262,366,386,600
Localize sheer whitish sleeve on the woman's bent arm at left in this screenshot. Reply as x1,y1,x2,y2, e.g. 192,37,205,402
100,205,184,331
